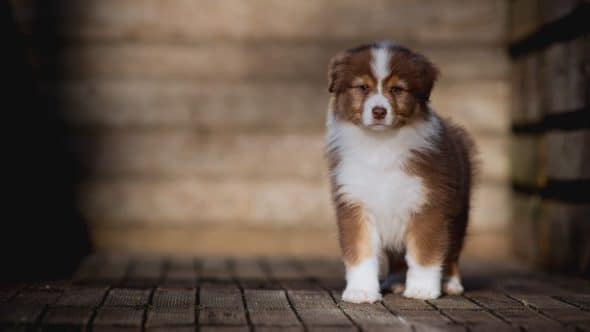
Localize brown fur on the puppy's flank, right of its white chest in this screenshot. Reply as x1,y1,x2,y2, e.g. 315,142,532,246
407,114,475,265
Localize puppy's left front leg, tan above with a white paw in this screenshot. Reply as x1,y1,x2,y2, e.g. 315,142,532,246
337,203,381,303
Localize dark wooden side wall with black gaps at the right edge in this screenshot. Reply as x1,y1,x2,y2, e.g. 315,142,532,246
509,0,590,274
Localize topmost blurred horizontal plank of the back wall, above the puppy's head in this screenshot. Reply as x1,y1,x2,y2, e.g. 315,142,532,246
10,0,506,43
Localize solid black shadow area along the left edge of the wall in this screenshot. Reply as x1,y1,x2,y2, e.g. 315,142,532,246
0,1,90,282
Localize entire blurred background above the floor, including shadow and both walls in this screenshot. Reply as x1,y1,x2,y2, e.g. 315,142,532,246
2,0,590,275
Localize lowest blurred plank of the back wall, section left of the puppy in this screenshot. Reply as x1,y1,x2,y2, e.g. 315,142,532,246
91,225,339,260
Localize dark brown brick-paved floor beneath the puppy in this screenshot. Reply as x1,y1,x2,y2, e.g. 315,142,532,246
0,255,590,332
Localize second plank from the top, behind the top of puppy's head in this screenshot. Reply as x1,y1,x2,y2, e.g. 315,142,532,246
45,42,508,84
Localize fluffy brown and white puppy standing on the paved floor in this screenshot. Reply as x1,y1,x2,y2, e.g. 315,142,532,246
326,43,474,302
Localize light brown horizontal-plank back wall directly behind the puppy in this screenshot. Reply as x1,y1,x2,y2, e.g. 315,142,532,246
13,0,509,256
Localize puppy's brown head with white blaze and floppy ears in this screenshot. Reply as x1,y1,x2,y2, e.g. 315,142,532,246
328,44,438,131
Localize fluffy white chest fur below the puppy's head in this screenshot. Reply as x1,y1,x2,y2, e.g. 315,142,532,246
327,116,439,249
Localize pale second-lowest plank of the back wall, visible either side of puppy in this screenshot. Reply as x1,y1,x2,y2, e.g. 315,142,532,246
81,178,509,232
